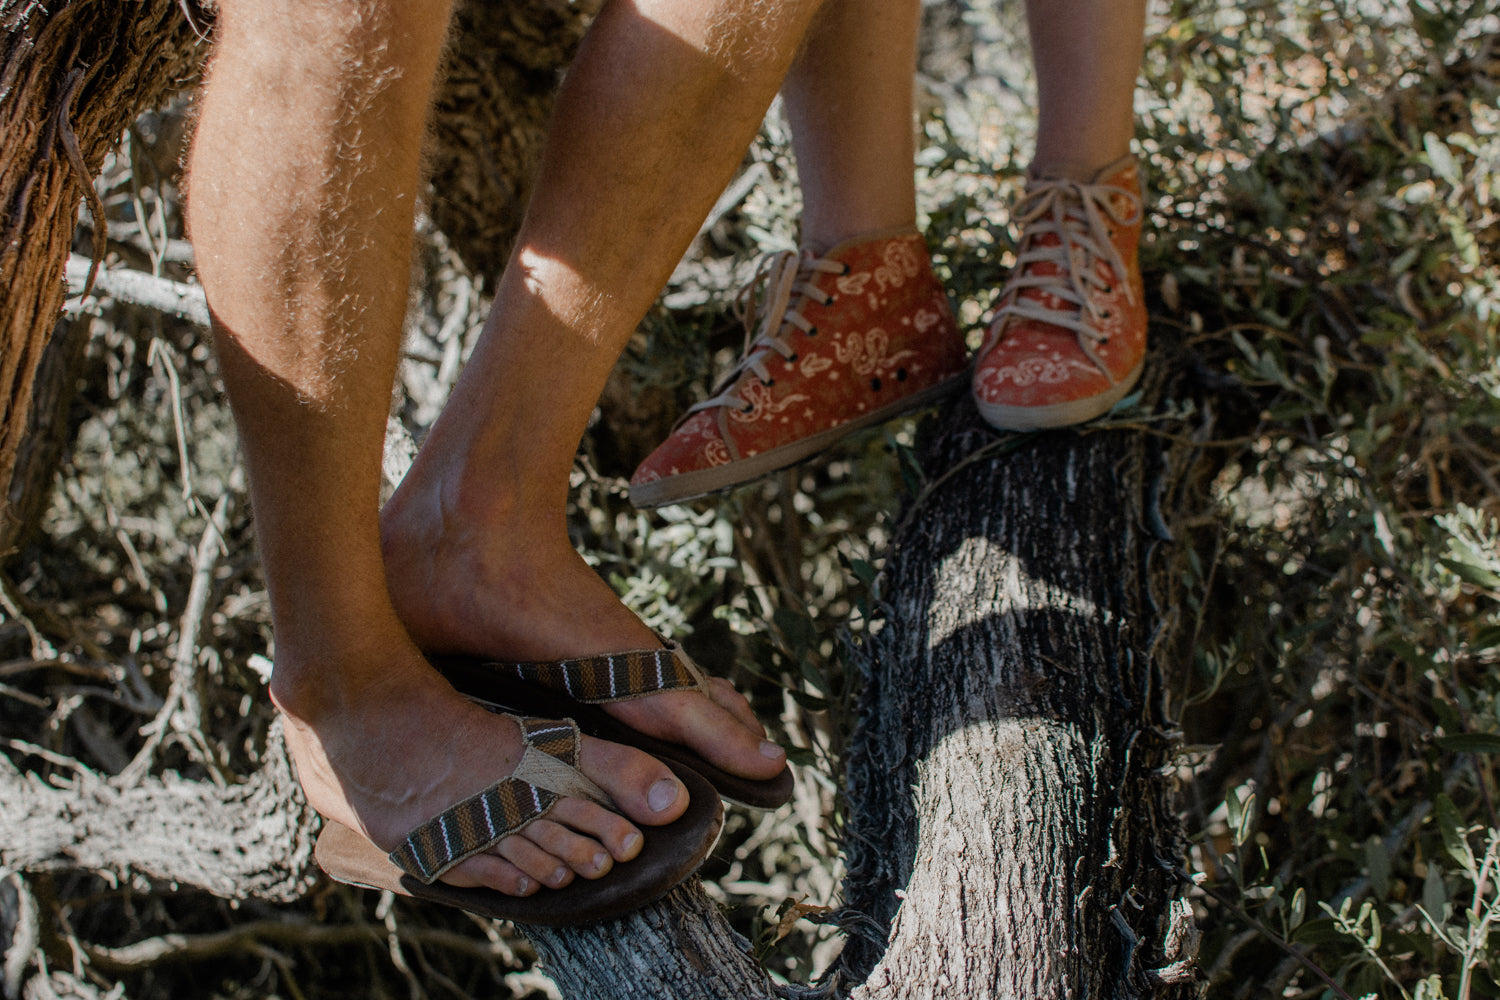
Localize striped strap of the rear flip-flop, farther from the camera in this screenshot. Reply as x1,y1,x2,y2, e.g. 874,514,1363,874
489,642,708,705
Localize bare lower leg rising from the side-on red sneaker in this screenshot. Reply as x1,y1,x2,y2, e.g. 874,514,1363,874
783,0,921,253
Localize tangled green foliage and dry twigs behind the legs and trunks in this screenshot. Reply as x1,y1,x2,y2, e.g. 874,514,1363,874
0,0,1500,999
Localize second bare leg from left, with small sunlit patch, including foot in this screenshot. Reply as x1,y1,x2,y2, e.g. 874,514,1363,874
383,0,818,778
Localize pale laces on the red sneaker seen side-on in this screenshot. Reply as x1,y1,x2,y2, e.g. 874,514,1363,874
684,250,849,415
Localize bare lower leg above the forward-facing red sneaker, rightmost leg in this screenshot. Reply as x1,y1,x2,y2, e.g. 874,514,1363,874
1026,0,1146,180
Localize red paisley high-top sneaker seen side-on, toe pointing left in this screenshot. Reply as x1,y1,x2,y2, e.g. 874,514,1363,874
630,229,968,507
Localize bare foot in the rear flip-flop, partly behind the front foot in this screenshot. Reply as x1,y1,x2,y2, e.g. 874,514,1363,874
381,476,786,780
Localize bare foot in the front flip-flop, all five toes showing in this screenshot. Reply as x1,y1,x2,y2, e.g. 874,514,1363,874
272,630,687,897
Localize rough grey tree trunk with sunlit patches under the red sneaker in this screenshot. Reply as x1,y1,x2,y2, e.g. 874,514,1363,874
840,386,1193,1000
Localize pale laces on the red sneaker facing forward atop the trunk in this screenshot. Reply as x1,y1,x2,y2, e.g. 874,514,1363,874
990,178,1143,370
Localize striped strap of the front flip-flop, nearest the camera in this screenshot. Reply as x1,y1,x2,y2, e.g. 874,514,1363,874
390,715,617,885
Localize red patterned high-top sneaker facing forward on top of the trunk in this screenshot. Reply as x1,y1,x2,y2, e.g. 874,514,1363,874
974,156,1146,430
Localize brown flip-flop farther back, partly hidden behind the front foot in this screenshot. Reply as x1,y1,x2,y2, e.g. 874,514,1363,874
428,642,794,810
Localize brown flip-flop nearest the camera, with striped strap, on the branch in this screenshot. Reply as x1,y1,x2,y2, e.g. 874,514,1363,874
314,717,725,927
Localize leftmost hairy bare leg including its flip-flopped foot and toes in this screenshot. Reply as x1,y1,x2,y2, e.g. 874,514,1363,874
191,0,686,895
